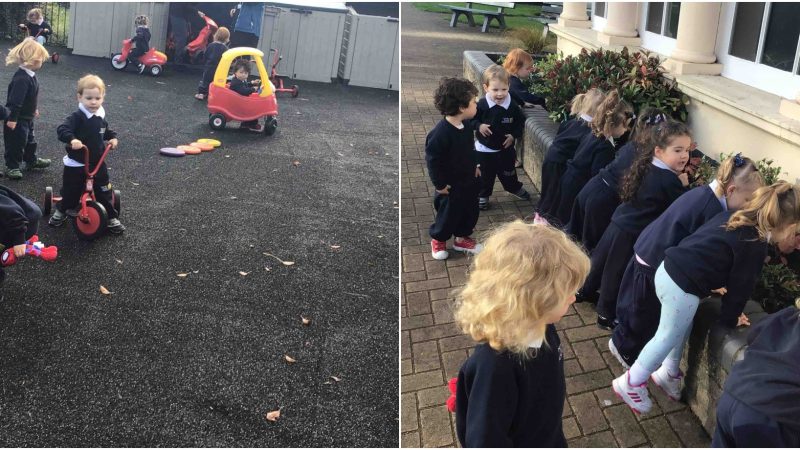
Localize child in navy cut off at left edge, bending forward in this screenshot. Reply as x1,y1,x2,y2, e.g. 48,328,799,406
0,185,42,285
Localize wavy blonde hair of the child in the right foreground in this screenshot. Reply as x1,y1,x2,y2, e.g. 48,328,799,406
455,220,589,355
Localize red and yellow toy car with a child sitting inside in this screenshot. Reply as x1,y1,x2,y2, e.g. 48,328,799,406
208,47,278,136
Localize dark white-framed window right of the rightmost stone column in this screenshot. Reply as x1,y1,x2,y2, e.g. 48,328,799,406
728,3,800,73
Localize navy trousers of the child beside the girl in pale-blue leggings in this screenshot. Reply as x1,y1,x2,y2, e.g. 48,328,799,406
611,257,661,365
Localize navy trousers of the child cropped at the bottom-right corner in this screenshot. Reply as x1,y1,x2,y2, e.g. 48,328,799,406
711,392,800,448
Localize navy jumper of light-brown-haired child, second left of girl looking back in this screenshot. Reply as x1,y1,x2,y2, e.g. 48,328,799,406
552,133,616,226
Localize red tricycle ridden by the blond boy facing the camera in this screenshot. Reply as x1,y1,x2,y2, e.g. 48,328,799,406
43,144,121,241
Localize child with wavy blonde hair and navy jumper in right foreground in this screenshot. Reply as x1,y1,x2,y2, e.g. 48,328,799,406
455,220,589,447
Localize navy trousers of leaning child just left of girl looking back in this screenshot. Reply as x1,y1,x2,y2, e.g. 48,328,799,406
565,175,619,253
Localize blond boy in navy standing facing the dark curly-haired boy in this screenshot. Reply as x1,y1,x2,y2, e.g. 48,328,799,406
469,65,531,209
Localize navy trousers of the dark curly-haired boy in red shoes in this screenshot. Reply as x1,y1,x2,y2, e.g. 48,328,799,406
429,178,481,242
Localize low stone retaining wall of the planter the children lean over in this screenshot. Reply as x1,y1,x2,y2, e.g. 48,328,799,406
464,51,767,436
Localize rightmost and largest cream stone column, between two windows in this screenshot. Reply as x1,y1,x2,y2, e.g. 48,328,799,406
664,2,722,75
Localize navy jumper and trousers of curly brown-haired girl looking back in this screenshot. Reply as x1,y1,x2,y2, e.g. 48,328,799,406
582,161,686,320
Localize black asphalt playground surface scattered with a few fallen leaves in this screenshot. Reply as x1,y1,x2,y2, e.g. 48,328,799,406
0,42,399,447
